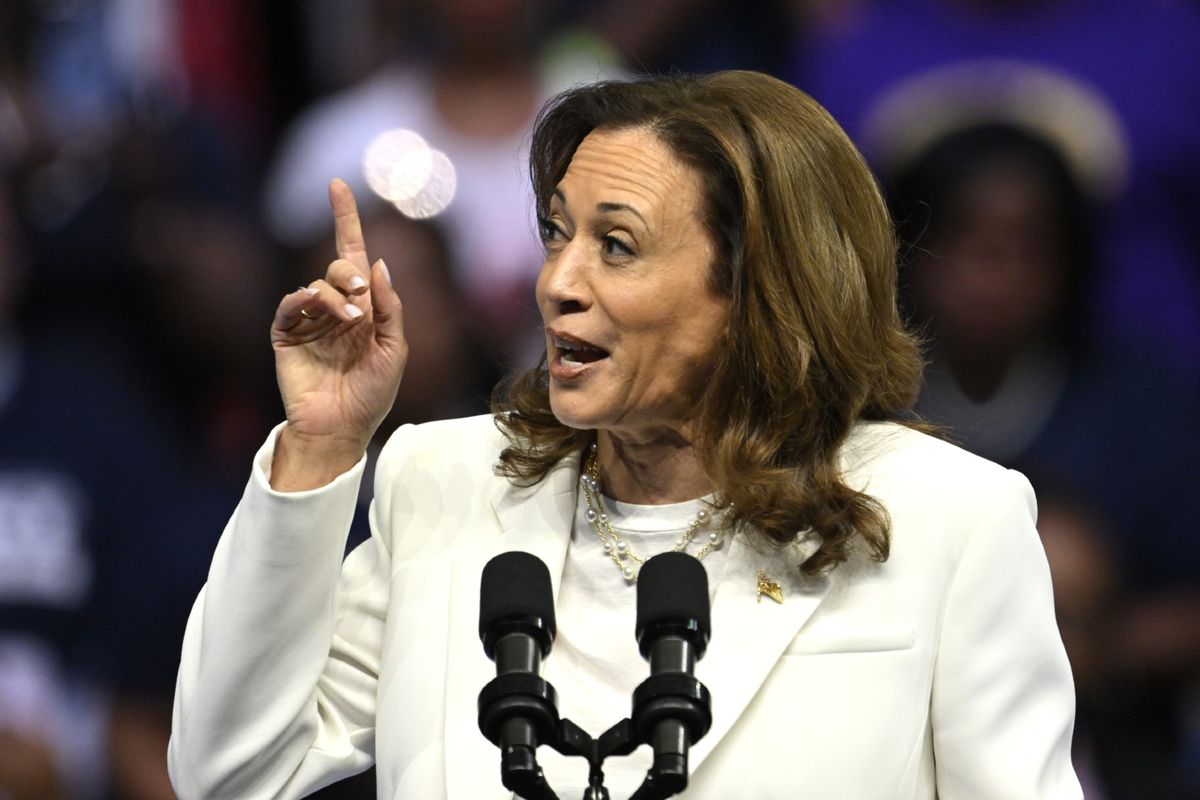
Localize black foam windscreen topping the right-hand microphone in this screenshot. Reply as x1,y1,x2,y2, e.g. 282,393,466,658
636,552,712,643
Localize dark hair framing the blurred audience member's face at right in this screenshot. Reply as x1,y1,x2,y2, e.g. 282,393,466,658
888,122,1093,350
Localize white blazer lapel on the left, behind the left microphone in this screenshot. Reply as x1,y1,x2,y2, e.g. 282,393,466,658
445,457,580,800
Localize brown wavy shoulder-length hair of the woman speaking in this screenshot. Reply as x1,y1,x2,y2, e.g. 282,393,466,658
492,72,922,575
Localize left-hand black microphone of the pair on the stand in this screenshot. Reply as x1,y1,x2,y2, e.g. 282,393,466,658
479,552,558,798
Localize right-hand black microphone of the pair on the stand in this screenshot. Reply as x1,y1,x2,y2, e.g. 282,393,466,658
631,552,713,799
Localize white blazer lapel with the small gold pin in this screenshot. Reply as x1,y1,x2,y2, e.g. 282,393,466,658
689,537,829,772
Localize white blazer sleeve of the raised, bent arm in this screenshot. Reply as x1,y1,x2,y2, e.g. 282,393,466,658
168,429,390,800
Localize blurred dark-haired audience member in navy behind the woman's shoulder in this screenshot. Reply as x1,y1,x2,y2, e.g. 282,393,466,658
889,124,1200,587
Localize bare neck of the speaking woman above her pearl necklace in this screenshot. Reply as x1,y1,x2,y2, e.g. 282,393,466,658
596,431,714,505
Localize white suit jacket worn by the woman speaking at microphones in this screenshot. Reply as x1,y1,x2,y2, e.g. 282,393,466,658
169,416,1081,800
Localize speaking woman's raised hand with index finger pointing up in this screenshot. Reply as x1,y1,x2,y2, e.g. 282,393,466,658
271,179,408,492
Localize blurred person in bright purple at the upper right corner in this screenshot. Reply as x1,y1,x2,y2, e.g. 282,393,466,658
788,0,1200,381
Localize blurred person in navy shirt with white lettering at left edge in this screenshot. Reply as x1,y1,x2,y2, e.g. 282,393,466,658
0,183,182,799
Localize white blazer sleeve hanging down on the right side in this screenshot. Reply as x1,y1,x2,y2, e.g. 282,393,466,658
931,471,1082,800
